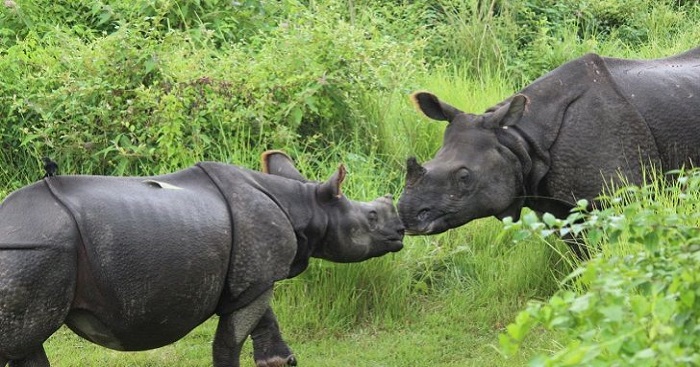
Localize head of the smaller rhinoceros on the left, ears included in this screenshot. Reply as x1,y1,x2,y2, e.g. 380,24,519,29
263,151,404,263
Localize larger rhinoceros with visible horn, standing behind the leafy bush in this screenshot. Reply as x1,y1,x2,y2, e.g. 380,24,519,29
398,48,700,256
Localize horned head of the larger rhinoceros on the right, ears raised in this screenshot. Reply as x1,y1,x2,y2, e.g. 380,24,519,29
398,92,527,234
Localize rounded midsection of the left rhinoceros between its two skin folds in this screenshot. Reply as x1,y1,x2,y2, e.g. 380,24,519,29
52,168,231,350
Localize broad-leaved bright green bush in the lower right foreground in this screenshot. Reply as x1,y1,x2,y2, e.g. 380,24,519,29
501,170,700,366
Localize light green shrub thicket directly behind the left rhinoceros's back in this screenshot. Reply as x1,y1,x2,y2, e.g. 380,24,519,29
0,1,420,180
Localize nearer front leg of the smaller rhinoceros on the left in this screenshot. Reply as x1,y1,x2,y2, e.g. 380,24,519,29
213,289,272,367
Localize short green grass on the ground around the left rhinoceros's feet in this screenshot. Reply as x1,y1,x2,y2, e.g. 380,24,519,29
46,309,553,367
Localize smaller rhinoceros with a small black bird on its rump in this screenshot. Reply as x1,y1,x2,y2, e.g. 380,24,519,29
0,152,404,367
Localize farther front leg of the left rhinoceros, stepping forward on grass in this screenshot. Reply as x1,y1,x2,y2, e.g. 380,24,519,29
250,308,297,367
